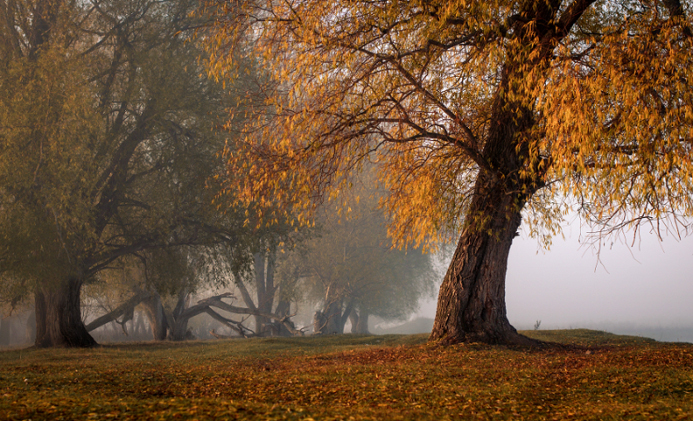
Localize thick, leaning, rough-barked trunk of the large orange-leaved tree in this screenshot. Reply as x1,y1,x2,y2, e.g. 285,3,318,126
430,61,543,345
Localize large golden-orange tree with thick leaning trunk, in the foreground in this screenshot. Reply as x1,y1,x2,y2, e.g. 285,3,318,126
209,0,693,343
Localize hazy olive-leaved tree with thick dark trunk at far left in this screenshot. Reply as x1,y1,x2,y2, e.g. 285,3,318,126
0,0,249,347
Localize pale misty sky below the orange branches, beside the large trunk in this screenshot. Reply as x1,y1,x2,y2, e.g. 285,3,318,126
419,222,693,329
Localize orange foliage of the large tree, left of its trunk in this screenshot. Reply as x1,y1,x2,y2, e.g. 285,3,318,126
204,1,497,245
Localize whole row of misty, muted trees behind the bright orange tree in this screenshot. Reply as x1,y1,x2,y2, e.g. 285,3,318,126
0,0,433,347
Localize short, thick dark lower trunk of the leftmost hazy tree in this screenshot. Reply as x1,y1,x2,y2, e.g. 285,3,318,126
34,278,96,348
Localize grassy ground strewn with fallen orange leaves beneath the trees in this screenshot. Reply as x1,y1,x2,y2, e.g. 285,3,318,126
0,330,693,420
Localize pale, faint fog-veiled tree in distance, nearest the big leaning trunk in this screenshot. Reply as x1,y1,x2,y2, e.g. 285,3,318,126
291,183,434,333
